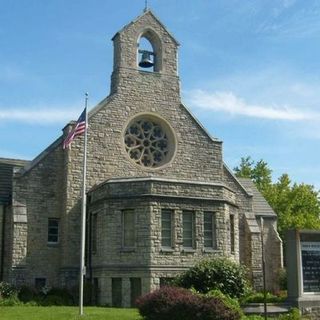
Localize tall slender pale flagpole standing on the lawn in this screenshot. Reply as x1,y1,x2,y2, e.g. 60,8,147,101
79,93,88,316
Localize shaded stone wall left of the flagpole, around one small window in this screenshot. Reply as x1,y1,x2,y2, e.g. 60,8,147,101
10,143,64,286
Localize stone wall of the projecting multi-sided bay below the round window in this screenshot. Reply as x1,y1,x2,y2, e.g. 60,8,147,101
89,179,239,306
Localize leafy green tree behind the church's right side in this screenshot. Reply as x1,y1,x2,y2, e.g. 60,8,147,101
234,157,320,239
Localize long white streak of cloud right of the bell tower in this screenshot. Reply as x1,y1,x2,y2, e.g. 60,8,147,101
187,90,320,121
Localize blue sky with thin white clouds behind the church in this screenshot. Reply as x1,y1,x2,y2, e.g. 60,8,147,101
0,0,320,189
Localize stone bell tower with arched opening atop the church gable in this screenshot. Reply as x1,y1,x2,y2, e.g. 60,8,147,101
111,9,180,98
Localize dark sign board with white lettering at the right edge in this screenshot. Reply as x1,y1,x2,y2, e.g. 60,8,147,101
301,242,320,293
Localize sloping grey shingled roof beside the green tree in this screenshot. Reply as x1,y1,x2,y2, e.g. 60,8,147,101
237,178,277,217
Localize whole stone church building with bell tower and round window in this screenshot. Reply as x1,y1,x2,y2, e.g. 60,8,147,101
0,10,282,306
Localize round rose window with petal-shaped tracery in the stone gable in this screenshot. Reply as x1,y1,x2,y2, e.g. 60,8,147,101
124,116,174,168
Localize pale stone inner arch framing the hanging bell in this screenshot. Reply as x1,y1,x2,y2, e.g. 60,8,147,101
137,28,162,72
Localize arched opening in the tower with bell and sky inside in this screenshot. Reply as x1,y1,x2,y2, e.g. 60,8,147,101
137,30,162,72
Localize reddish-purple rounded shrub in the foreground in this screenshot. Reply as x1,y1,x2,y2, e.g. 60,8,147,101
136,287,241,320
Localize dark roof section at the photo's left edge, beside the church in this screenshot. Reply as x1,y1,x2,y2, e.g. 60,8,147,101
0,158,29,204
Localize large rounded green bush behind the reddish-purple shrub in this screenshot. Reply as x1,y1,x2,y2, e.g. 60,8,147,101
173,258,249,298
